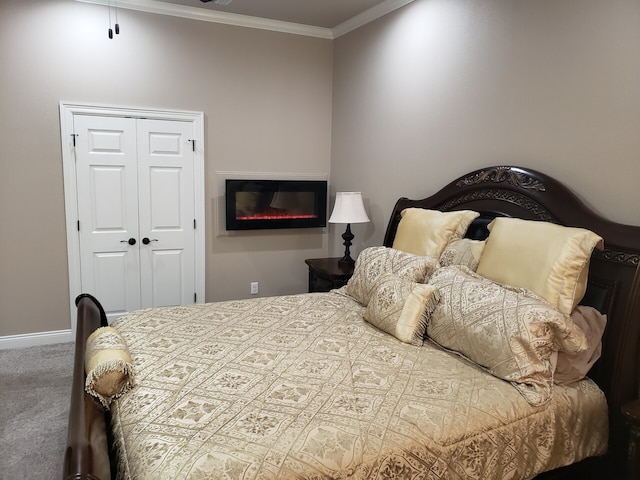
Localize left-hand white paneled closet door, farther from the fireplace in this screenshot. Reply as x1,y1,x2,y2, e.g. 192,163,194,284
74,115,140,321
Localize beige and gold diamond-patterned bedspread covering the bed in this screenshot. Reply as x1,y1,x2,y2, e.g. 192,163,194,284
112,292,607,480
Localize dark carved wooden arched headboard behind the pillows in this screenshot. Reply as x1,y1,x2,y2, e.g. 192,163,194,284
384,166,640,478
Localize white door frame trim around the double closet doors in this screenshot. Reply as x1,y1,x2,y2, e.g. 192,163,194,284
60,102,205,338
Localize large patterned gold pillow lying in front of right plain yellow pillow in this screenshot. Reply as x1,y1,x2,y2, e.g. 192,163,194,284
427,266,587,406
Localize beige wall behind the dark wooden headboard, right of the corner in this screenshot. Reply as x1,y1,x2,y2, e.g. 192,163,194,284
331,0,640,258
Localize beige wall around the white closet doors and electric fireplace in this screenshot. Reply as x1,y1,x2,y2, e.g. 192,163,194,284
0,0,332,337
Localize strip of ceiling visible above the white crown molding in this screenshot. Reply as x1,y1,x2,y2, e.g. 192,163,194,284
155,0,388,28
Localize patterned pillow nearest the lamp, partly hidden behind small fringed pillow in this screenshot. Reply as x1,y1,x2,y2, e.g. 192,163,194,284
345,247,440,307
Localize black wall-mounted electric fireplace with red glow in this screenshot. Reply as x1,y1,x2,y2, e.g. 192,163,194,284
225,179,327,230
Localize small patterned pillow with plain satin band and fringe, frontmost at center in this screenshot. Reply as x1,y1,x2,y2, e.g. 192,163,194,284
364,273,440,345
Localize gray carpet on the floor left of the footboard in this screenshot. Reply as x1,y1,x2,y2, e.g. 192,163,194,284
0,343,74,480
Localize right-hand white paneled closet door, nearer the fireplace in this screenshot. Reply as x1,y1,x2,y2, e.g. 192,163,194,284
137,119,196,308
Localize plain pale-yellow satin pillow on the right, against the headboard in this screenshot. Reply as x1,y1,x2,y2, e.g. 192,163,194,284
477,217,603,315
